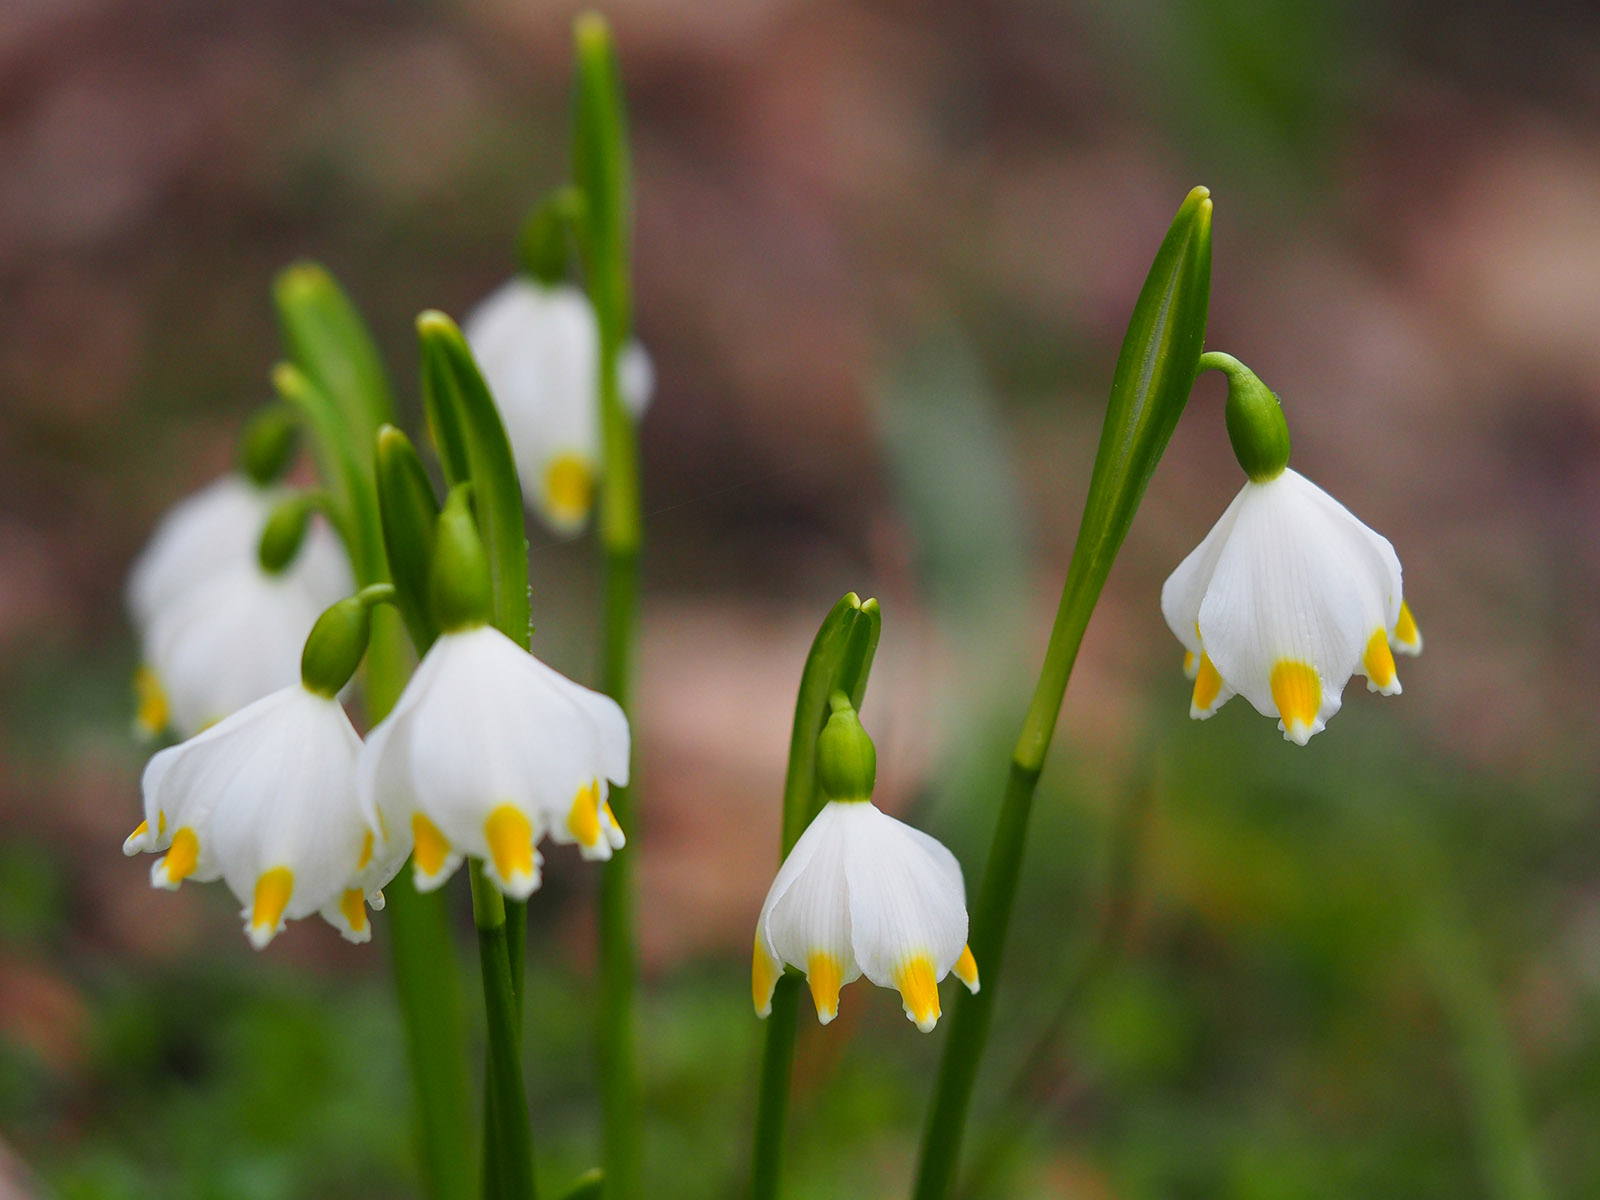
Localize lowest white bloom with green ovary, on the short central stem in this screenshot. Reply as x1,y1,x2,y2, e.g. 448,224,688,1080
750,694,978,1034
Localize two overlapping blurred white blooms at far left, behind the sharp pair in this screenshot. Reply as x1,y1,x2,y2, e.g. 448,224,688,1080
128,478,354,736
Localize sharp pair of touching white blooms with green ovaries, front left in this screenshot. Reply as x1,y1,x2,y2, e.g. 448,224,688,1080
123,490,629,949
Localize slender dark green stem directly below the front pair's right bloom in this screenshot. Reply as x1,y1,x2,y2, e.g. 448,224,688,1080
469,859,536,1200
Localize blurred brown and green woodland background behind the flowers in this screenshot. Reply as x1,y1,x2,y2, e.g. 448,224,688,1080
0,0,1600,1200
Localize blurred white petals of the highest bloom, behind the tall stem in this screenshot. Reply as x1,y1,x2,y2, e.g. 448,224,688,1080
462,275,654,533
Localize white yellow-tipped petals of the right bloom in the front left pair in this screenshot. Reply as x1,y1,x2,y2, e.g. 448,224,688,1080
358,622,629,899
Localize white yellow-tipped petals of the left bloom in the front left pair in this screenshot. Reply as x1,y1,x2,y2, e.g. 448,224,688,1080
123,682,403,949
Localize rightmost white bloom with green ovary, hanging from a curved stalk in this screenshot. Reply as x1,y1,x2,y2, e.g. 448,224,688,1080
1162,354,1422,746
